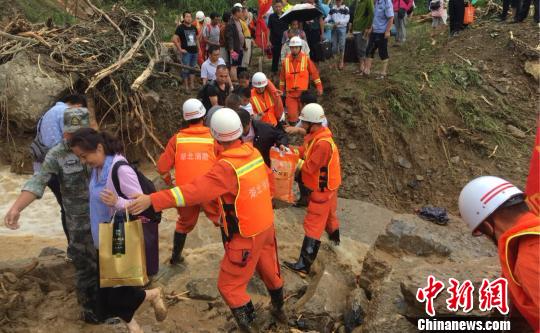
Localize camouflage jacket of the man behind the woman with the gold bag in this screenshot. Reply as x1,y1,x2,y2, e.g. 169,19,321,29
22,140,90,216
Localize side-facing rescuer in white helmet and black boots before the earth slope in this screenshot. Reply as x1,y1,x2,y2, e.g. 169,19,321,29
285,103,341,275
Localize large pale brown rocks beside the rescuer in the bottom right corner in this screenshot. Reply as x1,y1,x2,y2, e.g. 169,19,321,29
355,215,499,333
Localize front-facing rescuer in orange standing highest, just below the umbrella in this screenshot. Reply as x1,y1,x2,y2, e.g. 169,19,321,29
279,37,323,124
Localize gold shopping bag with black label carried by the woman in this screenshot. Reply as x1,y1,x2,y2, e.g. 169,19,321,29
99,214,148,288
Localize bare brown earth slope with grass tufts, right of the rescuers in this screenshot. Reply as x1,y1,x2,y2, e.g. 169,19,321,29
314,20,539,212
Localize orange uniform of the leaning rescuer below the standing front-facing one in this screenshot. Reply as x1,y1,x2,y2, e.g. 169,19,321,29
250,81,283,127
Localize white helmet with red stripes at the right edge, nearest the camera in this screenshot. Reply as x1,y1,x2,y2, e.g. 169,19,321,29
459,176,523,232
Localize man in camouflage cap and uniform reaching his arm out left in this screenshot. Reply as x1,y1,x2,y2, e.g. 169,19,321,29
4,108,99,323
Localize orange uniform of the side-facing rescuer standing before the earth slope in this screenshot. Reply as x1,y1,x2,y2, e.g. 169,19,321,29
299,127,341,240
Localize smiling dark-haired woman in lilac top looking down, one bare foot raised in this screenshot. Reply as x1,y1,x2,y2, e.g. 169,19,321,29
70,128,167,333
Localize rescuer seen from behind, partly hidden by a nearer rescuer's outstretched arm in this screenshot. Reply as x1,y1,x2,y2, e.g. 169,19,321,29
157,98,220,265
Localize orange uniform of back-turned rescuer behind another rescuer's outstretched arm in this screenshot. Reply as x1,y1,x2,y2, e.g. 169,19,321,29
157,124,221,234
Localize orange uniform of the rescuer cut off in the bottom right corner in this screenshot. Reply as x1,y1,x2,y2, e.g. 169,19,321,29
498,213,540,332
